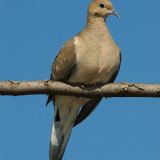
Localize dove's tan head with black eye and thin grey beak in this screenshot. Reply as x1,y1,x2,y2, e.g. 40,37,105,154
88,0,119,19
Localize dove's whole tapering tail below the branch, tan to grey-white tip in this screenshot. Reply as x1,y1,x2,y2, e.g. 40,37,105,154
49,96,86,160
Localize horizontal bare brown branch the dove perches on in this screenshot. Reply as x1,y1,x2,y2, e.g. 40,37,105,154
0,81,160,98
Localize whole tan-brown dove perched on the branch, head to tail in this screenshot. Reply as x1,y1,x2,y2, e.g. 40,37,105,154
47,0,121,160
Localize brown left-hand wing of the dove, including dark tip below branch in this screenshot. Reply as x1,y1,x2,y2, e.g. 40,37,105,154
46,39,76,105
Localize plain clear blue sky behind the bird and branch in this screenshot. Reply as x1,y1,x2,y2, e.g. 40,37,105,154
0,0,160,160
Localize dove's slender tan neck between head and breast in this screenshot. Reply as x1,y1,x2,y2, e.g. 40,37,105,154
86,15,111,37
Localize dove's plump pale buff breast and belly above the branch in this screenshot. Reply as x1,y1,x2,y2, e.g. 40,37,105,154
69,37,120,84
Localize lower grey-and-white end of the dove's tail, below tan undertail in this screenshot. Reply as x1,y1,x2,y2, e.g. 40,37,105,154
49,121,73,160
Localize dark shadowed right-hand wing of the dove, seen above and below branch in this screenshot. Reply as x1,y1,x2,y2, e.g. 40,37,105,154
74,51,122,126
